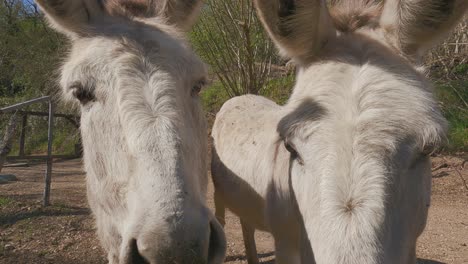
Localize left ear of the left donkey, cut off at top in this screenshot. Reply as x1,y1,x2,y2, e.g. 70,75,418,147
36,0,105,37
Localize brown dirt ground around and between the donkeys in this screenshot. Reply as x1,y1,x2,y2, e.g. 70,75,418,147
0,155,468,264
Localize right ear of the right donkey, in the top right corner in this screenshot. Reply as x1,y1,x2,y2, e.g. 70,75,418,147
380,0,468,59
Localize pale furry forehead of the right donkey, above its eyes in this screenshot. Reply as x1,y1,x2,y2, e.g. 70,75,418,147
286,57,446,151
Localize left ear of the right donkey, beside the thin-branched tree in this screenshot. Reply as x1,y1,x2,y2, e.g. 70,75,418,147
254,0,335,61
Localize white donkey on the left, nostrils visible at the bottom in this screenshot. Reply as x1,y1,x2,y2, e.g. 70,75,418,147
37,0,226,264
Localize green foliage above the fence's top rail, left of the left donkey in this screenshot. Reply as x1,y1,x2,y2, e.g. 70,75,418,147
0,0,65,105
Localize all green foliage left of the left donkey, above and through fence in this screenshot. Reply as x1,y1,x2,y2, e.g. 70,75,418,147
0,0,78,154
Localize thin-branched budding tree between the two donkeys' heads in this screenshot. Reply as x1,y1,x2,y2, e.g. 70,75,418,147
192,0,282,97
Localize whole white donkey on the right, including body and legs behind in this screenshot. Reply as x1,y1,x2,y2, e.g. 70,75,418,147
212,0,468,264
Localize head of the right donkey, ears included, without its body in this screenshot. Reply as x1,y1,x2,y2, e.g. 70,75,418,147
255,0,468,264
